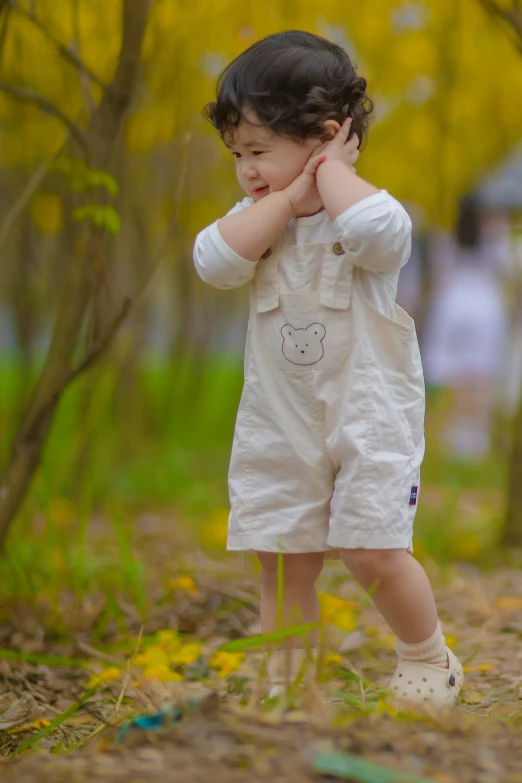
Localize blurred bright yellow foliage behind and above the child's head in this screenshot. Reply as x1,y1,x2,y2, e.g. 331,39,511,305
0,0,522,231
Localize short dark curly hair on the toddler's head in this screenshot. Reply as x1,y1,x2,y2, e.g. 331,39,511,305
203,30,373,149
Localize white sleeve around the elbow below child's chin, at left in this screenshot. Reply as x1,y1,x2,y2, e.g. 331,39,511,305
194,198,257,288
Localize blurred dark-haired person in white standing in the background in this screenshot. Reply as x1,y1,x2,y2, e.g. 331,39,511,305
423,194,511,459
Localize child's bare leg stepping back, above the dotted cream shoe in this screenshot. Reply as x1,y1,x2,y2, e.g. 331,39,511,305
340,549,438,644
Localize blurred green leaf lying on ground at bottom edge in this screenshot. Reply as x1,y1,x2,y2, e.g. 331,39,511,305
314,751,435,783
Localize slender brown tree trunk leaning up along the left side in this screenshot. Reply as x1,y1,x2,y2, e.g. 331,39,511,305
0,0,149,547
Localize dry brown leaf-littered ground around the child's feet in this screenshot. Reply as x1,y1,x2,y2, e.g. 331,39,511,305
0,524,522,783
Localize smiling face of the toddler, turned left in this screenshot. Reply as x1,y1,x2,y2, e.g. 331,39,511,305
225,113,321,201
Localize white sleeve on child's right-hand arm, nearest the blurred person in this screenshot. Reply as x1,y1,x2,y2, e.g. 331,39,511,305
333,190,411,273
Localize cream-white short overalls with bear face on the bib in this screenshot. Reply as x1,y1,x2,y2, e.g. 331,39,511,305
196,194,424,552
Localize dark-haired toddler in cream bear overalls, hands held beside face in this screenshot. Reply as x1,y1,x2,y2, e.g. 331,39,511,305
194,31,462,706
